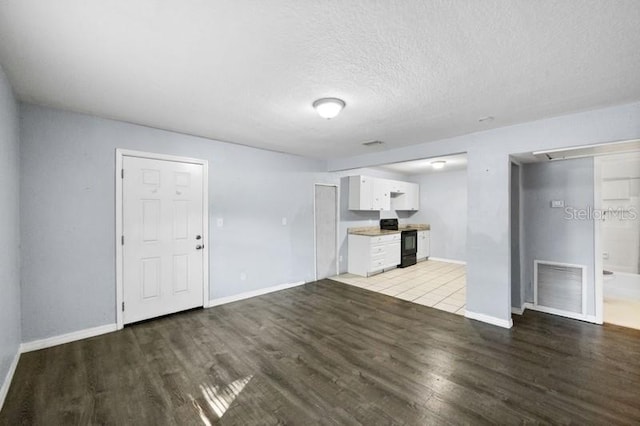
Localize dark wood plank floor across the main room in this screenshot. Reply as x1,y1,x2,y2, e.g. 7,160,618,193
0,280,640,425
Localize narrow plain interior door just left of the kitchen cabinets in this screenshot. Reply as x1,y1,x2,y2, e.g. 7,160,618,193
313,183,339,280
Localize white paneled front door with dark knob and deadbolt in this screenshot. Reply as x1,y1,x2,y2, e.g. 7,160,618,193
122,156,206,324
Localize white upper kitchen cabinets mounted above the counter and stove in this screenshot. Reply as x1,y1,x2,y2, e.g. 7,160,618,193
349,176,420,211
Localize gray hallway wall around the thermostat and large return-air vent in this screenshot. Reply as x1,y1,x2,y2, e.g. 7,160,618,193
522,158,595,315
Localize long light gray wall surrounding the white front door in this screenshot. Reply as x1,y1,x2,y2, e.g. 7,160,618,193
21,104,326,341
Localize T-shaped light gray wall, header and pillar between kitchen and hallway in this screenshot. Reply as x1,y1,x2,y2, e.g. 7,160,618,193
328,103,640,321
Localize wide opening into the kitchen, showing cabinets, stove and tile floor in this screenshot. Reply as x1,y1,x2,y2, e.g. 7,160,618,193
331,153,468,316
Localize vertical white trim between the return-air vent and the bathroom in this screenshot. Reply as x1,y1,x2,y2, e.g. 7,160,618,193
593,157,604,324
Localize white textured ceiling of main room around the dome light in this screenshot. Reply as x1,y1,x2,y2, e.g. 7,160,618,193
0,0,640,158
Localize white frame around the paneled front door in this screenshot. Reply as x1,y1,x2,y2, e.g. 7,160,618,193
115,148,211,330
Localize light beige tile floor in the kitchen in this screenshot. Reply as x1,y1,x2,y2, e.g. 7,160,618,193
329,260,467,315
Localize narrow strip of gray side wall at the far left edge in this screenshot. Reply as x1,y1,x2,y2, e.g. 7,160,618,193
0,64,21,386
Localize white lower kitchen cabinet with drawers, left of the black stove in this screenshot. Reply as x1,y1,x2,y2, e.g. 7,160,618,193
347,233,400,277
